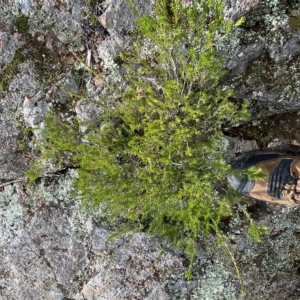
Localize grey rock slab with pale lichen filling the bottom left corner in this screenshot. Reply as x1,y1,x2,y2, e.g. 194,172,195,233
0,171,88,300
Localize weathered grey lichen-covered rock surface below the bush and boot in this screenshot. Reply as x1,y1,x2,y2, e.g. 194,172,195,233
0,171,300,300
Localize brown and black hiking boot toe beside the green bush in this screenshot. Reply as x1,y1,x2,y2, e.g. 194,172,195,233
228,153,300,205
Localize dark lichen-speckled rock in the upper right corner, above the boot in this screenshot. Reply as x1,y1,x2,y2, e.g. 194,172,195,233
227,1,299,119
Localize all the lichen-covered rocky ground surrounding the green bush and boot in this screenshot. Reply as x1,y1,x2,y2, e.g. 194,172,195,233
0,0,300,300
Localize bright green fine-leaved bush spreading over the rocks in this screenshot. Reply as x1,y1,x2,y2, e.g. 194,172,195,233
29,0,253,277
